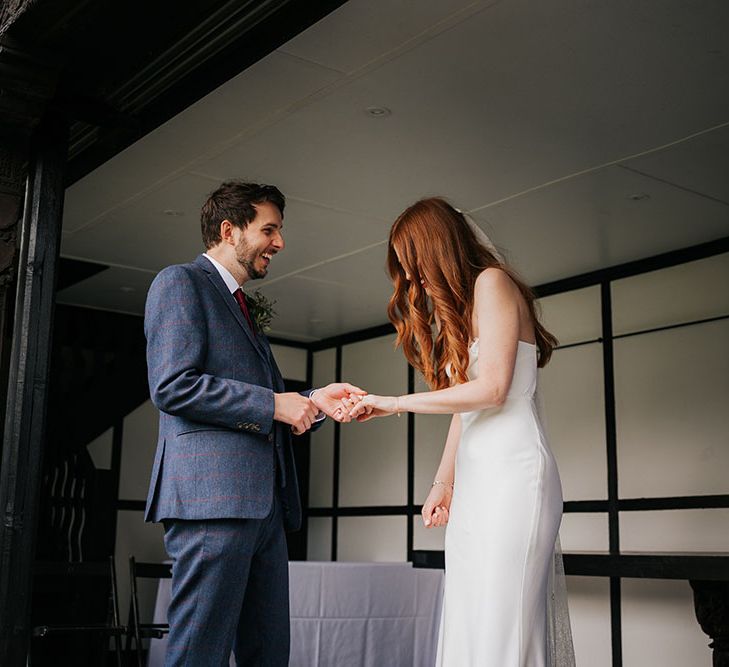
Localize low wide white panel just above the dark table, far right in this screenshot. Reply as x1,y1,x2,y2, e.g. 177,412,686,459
620,508,729,551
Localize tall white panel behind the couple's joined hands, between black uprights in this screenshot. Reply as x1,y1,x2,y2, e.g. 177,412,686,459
339,336,408,506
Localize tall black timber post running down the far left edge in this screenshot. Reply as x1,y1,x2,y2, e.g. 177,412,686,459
0,112,68,667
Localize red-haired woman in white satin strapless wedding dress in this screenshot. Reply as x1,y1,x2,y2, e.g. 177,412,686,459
347,198,574,667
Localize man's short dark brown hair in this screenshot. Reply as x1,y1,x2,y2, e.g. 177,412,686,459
200,181,286,250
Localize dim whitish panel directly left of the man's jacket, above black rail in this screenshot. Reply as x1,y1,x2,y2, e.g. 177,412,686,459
119,401,159,500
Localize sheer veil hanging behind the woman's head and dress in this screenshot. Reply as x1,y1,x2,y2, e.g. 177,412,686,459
456,209,575,667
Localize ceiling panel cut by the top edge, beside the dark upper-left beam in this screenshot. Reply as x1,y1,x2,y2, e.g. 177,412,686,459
280,0,486,73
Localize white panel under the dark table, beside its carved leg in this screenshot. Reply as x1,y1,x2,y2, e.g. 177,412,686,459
621,579,711,667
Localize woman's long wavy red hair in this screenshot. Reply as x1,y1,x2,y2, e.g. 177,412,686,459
387,197,557,389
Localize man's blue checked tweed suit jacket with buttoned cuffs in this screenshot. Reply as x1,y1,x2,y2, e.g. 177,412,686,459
144,255,301,530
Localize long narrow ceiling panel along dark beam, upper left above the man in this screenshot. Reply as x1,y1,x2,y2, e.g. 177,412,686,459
64,52,338,231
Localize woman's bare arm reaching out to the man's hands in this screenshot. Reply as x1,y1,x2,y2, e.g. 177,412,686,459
351,269,520,421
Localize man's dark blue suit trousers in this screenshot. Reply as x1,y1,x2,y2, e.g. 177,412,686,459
164,493,290,667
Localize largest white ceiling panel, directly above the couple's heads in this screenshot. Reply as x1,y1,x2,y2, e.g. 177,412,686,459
196,2,729,217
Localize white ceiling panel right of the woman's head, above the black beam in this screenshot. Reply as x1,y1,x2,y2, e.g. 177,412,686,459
474,166,729,284
